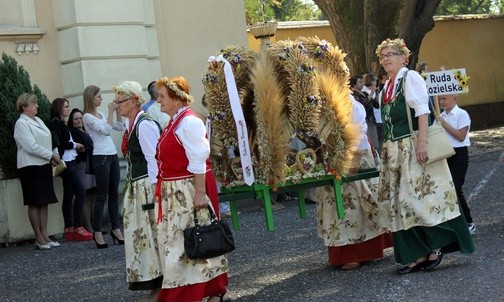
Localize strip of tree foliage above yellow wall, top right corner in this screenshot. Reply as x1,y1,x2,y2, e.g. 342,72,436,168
436,0,504,15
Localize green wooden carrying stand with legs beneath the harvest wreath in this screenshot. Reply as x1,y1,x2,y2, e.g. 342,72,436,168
219,169,379,232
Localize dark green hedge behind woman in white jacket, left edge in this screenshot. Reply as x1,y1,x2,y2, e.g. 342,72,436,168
0,52,51,179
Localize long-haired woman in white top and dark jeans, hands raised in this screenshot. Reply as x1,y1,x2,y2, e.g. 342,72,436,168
83,85,124,248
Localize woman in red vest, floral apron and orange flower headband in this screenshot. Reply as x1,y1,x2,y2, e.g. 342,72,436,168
156,77,229,302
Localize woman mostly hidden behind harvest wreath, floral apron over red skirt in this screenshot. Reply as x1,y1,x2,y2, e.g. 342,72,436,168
317,97,392,270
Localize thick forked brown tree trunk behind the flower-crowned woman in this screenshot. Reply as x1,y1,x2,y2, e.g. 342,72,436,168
313,0,441,74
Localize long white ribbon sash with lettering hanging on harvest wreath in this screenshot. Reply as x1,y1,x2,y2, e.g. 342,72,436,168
208,55,255,186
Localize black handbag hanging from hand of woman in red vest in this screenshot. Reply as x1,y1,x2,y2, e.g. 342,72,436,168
184,204,235,259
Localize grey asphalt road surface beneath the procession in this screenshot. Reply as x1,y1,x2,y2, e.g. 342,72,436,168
0,128,504,302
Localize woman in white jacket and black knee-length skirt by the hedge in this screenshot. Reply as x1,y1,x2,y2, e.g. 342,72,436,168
14,93,60,250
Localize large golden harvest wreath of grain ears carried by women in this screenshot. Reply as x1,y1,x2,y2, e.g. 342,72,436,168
203,37,359,187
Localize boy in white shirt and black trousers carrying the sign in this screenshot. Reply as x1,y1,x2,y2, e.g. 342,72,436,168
439,94,476,235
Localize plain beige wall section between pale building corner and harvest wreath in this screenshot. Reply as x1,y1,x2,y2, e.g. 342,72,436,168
154,0,247,114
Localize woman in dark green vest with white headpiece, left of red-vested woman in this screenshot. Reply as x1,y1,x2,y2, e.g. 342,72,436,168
112,81,163,292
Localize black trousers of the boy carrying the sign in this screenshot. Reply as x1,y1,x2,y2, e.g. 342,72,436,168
448,147,473,223
